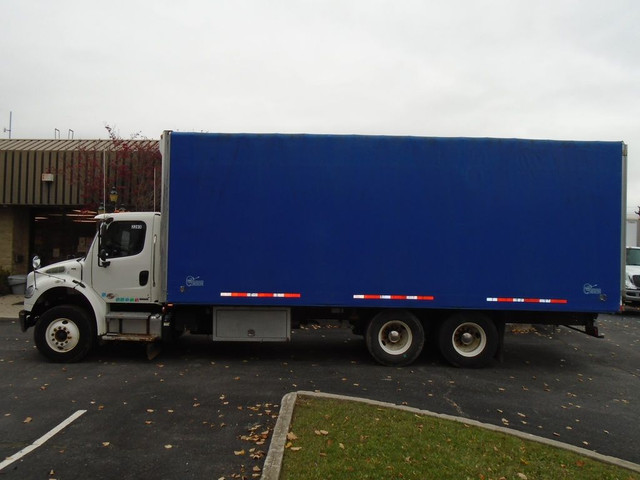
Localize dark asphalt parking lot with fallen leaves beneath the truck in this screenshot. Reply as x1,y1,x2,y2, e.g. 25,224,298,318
0,308,640,479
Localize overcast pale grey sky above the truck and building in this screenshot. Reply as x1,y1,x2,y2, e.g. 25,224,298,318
0,0,640,213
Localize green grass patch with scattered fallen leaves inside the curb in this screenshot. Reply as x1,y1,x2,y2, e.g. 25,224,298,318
280,396,640,480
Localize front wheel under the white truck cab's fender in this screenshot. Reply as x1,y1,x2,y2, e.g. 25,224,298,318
33,305,96,363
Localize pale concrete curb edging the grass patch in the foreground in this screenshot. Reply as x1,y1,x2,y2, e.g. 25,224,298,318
262,391,640,480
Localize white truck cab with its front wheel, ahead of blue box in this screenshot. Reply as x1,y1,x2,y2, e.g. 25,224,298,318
20,212,161,362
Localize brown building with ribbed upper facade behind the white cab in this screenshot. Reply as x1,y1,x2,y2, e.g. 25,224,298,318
0,140,160,275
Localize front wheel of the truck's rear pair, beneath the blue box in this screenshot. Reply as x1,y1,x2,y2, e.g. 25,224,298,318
365,310,424,367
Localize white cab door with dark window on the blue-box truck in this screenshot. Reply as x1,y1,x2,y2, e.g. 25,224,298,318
91,218,154,303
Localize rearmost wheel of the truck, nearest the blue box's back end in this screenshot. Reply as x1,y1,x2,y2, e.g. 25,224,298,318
438,312,499,368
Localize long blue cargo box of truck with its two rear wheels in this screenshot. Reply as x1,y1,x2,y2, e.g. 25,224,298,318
162,132,626,366
